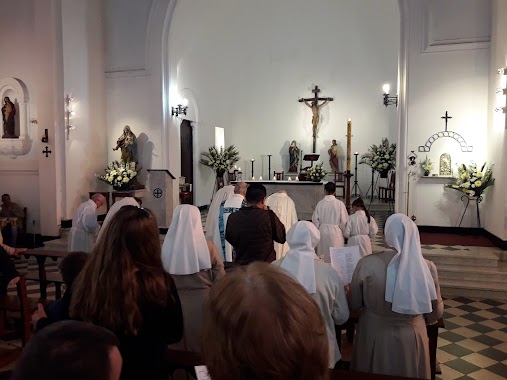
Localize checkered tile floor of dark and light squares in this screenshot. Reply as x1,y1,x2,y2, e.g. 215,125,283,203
6,211,507,380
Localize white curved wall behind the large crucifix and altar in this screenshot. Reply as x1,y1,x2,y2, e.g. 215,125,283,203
168,0,399,205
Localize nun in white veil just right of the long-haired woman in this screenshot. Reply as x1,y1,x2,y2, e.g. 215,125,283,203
162,204,225,352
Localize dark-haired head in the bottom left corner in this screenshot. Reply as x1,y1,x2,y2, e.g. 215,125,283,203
11,321,122,380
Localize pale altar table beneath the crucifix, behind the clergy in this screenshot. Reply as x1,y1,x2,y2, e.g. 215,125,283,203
237,181,324,220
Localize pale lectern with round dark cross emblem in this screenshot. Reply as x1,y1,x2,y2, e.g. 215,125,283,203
143,169,176,227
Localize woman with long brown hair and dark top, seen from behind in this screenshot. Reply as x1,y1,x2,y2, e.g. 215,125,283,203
70,206,183,380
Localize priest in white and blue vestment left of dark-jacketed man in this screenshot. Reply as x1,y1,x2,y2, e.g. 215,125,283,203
213,182,248,262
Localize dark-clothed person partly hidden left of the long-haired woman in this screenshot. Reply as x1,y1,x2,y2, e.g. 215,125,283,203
32,252,89,330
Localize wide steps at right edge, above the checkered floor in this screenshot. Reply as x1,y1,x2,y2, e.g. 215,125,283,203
424,251,507,301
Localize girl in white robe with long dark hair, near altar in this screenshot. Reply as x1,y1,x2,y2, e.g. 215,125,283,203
343,198,378,257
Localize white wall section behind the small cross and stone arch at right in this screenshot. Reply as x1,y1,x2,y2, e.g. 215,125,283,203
398,0,491,227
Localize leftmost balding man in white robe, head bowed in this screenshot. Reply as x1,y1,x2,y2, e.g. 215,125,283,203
69,193,106,252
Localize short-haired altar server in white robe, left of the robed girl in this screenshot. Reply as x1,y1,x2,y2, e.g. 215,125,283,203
312,182,349,263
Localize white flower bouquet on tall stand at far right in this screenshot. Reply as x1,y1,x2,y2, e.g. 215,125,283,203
446,162,495,197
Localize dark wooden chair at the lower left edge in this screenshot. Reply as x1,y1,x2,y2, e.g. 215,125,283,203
0,274,37,347
